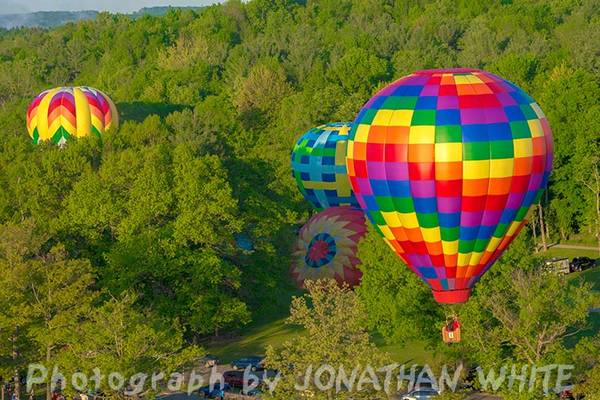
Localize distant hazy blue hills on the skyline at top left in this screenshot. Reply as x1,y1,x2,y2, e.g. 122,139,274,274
0,6,202,29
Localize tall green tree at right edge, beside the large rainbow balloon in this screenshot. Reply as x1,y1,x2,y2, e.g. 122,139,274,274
537,64,600,241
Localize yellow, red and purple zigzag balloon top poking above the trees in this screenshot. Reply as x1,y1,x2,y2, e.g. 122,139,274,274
27,86,119,144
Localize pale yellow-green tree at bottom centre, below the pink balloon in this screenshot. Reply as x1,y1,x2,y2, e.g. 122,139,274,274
265,280,389,399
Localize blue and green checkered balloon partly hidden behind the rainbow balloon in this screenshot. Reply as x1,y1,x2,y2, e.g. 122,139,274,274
292,122,358,210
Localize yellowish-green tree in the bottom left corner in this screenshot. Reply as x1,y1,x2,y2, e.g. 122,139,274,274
0,222,96,399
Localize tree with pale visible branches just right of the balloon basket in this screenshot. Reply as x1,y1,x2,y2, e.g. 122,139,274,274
461,269,594,364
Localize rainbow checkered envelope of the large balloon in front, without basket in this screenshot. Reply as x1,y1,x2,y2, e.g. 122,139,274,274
347,69,553,303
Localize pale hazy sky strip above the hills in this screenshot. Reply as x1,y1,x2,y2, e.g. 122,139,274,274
0,0,218,14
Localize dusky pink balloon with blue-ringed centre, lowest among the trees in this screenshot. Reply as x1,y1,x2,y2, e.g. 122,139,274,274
290,206,367,288
